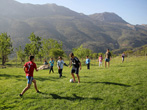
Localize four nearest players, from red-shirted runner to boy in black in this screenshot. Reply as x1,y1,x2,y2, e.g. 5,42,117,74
19,53,81,97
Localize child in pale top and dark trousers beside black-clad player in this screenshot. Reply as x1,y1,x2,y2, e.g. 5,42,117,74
57,56,68,78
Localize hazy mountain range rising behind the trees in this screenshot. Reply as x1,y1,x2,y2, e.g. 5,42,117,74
0,0,147,52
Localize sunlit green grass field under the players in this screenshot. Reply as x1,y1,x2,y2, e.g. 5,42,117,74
0,57,147,110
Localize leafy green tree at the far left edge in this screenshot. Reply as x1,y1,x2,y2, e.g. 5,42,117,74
0,33,13,65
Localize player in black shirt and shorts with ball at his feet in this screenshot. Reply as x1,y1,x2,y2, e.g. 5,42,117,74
69,53,82,83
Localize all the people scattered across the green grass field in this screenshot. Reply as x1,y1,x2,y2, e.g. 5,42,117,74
19,49,125,97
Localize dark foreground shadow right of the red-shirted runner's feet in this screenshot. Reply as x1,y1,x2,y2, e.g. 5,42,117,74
50,94,103,101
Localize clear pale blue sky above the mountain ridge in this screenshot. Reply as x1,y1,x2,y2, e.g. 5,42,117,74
16,0,147,25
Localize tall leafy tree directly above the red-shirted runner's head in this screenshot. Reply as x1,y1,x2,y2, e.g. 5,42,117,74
24,33,41,56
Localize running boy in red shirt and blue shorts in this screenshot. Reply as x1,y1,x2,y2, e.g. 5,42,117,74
20,56,40,97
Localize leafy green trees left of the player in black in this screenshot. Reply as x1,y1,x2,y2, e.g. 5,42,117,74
0,33,65,65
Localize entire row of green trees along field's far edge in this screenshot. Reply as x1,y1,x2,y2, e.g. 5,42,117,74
0,32,143,65
